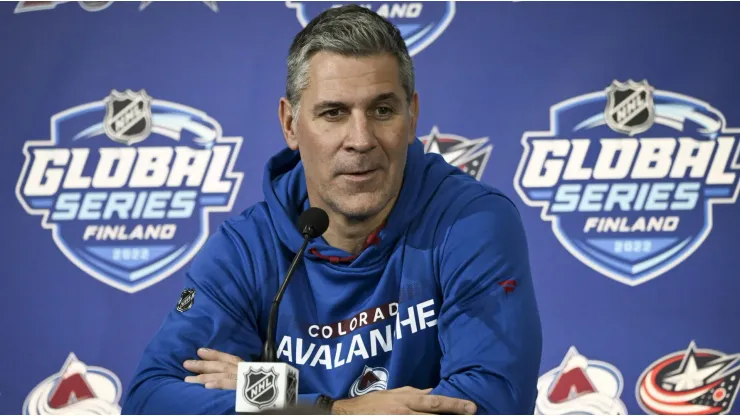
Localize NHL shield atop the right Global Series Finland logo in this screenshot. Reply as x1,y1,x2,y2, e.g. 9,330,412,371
604,80,655,136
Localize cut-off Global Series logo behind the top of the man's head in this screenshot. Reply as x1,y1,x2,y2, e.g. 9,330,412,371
286,1,455,56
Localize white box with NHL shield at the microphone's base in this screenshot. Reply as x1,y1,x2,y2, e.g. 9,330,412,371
236,362,298,412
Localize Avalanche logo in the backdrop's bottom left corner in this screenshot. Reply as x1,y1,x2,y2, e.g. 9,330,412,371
23,353,123,415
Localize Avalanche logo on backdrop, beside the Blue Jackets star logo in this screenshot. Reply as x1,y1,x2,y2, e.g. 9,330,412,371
534,347,627,415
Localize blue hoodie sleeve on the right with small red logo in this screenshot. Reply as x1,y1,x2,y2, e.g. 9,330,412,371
431,194,542,415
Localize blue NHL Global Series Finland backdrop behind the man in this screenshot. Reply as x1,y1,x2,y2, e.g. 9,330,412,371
0,1,740,414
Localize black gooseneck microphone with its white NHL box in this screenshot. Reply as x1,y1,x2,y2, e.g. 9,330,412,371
235,207,329,413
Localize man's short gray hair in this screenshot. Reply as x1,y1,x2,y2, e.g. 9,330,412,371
285,4,415,118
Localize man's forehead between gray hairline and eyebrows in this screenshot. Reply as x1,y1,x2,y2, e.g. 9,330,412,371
304,51,404,101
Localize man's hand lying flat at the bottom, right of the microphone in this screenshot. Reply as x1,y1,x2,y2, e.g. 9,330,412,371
331,387,477,415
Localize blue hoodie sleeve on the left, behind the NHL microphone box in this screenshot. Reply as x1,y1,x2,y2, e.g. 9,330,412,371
122,224,315,415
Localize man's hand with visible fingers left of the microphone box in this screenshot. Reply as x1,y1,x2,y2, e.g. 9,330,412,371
183,348,244,390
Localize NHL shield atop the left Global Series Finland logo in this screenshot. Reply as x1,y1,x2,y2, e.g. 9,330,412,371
103,90,152,145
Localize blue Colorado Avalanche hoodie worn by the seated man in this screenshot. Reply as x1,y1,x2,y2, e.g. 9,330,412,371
123,140,542,414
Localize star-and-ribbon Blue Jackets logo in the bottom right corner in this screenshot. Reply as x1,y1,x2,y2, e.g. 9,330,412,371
635,341,740,415
